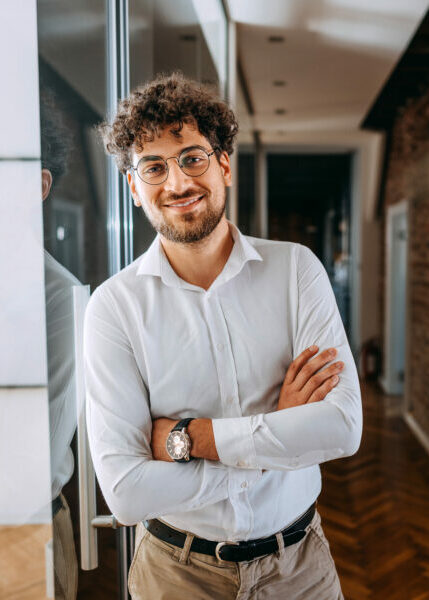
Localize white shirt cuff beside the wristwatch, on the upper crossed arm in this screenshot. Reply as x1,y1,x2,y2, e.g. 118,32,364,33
212,417,259,469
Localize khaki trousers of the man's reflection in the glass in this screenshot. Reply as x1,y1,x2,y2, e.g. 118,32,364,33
52,494,78,600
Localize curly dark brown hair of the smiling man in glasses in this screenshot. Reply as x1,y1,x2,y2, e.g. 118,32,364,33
97,72,238,173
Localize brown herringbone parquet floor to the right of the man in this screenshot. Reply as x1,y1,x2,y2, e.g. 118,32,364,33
318,383,429,600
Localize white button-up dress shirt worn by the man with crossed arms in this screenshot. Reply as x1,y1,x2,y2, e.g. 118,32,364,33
84,223,362,541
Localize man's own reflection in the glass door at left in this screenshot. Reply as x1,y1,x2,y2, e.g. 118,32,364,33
40,87,79,598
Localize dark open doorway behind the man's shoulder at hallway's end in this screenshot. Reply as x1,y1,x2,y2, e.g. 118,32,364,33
267,152,353,339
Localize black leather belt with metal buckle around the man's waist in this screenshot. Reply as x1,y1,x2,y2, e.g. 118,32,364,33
143,503,316,562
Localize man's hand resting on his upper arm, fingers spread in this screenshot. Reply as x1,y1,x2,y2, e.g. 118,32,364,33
277,346,344,410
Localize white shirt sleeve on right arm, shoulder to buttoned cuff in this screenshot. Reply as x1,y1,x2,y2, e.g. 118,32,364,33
213,244,362,470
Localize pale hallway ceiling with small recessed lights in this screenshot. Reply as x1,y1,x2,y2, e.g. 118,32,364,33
227,0,429,143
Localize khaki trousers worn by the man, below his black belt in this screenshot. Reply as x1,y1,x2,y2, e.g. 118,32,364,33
128,511,343,600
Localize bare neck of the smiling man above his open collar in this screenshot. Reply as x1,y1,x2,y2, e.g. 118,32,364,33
161,215,234,290
